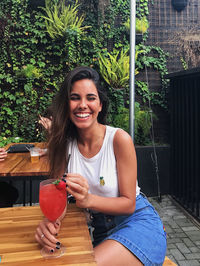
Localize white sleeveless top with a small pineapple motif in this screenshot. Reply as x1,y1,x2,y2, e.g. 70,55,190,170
68,126,140,197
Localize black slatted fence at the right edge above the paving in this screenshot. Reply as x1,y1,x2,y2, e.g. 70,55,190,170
166,68,200,221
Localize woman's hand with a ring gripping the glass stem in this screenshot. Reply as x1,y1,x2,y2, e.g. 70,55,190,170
35,218,61,253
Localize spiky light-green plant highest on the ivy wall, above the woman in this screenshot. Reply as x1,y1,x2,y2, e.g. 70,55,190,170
41,0,88,39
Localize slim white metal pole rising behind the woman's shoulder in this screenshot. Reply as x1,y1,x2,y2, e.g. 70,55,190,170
129,0,136,140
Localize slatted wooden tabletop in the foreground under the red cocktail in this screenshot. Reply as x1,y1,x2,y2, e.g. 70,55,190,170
0,204,96,266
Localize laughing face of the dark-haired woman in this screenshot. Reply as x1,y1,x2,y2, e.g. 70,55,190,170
69,79,102,129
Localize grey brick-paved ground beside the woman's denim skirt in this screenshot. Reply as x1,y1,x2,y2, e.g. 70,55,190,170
148,195,200,266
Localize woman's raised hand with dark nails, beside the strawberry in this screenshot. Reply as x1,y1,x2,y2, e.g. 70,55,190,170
66,173,89,208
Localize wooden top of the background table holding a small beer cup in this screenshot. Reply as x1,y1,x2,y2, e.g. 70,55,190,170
0,143,49,177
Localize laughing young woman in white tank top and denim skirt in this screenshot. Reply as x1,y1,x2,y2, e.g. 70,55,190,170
35,67,166,266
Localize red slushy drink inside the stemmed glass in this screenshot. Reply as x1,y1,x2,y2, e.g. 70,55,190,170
40,183,67,221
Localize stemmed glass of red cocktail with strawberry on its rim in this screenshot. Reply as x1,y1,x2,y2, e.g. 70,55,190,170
39,179,67,258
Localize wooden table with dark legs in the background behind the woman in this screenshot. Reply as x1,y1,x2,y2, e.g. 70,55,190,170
0,143,49,205
